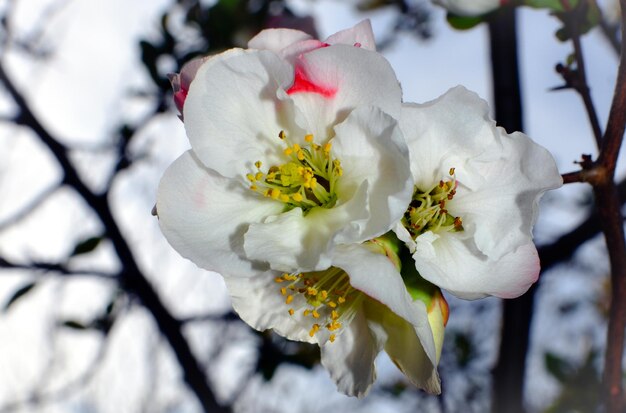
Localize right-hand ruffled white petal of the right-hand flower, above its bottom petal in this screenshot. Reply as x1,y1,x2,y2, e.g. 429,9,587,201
448,128,563,259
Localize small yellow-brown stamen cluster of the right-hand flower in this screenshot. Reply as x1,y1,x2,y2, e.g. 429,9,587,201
402,168,463,238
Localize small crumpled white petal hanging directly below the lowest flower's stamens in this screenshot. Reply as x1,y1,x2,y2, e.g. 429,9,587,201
321,311,386,397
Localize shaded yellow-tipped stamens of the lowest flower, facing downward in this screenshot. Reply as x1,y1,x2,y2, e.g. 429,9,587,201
274,267,364,343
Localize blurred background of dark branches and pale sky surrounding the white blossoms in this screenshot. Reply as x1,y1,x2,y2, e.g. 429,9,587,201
0,0,626,413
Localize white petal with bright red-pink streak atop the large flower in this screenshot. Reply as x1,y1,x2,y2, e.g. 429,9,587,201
289,45,402,141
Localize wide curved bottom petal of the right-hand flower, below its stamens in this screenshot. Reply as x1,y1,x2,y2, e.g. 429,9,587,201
413,232,540,300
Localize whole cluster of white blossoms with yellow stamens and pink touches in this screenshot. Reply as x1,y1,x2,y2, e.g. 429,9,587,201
157,21,561,396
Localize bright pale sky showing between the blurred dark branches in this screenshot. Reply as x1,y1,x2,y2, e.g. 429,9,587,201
0,0,624,413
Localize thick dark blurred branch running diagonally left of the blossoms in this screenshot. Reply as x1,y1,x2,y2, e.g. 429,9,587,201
0,64,230,413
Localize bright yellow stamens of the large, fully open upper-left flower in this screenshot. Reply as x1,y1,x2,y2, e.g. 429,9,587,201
246,131,343,213
